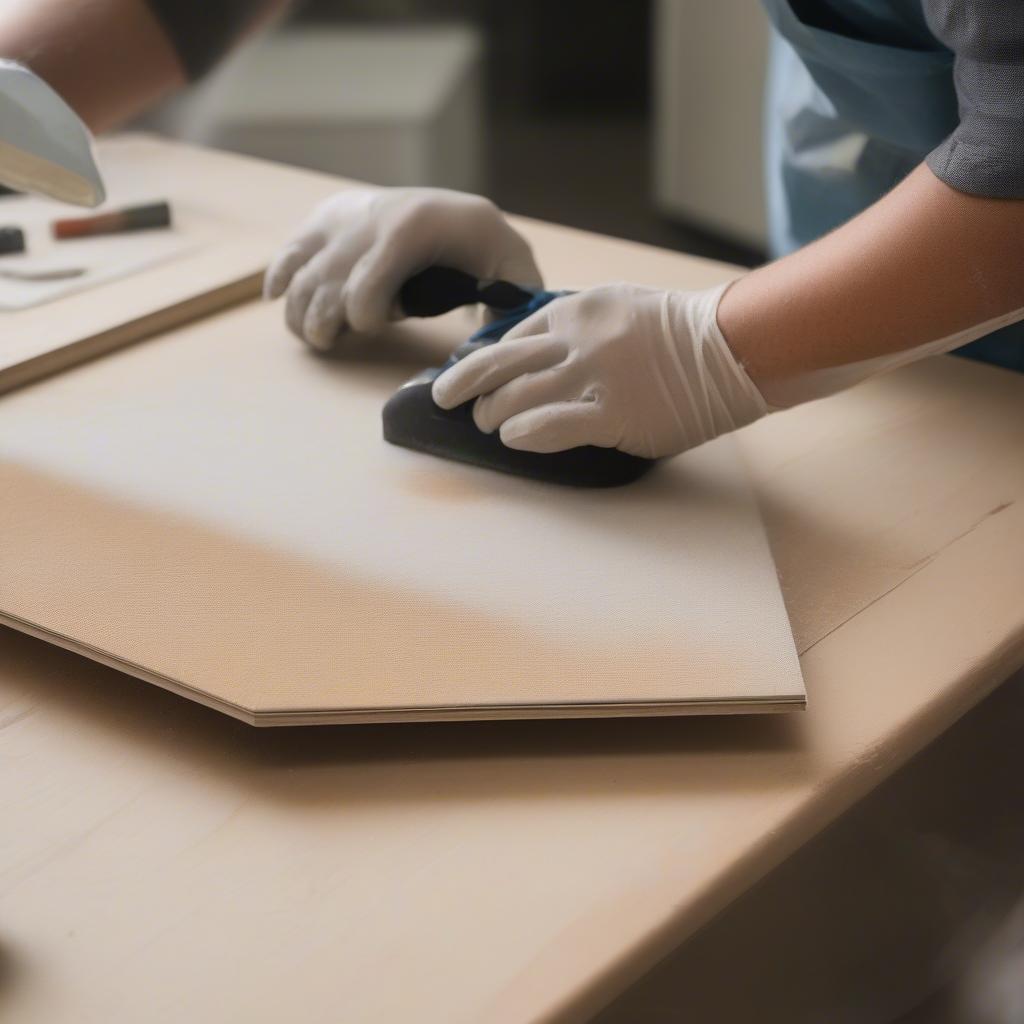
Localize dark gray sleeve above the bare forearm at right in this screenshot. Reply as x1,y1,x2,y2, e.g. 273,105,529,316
924,0,1024,199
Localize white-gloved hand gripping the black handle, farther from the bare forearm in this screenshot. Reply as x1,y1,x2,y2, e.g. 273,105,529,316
263,188,542,349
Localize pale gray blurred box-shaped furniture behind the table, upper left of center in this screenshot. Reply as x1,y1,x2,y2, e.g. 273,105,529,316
141,25,483,191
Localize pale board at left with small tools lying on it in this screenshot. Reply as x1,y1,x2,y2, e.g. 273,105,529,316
0,137,273,393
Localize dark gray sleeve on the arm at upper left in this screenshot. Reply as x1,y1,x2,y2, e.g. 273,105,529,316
148,0,267,79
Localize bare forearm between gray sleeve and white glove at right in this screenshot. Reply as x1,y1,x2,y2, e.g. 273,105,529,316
718,166,1024,382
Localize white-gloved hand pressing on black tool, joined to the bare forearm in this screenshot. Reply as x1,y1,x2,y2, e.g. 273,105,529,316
432,285,769,459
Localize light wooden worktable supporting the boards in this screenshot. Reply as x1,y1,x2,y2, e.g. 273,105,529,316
6,139,1024,1024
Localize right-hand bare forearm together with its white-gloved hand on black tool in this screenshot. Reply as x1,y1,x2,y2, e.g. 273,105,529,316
431,160,1024,459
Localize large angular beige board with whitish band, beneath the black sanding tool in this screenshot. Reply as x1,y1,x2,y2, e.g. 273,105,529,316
0,304,804,724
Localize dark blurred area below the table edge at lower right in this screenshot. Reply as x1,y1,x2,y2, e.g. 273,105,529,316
593,672,1024,1024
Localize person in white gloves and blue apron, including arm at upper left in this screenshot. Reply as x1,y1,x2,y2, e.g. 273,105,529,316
0,0,1024,457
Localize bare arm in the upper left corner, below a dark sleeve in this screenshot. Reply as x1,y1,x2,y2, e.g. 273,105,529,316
0,0,287,132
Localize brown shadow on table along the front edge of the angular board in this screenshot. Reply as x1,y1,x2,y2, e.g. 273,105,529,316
0,628,813,804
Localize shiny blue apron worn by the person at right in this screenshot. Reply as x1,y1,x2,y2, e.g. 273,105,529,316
764,0,1024,372
